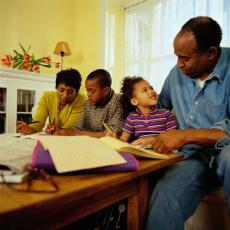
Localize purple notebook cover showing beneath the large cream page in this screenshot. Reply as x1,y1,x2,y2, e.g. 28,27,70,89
32,141,140,172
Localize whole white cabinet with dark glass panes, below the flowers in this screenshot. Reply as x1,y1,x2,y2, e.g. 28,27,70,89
0,67,56,133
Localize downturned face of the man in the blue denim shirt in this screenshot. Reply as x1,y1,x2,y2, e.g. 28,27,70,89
173,32,210,79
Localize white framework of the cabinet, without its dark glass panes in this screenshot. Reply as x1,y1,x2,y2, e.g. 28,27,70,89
0,67,56,133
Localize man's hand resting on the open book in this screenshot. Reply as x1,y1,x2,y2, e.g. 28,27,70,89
152,129,186,153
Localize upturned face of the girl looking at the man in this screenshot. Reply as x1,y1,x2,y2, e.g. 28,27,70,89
131,80,157,108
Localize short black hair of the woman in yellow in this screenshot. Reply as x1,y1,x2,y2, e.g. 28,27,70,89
56,69,82,92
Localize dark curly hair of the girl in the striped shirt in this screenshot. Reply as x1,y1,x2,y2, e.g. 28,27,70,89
121,76,144,118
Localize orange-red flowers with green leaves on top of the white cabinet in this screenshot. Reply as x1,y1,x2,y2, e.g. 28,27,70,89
1,43,60,73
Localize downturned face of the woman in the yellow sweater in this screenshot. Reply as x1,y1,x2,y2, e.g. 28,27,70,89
57,83,77,105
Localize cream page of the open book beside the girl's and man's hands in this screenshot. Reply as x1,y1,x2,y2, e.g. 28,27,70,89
100,136,170,159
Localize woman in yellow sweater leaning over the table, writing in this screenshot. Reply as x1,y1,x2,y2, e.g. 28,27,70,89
17,69,86,134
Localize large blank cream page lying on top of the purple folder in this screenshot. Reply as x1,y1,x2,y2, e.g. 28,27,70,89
39,136,126,173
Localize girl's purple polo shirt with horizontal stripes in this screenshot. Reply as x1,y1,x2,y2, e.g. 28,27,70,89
123,108,177,138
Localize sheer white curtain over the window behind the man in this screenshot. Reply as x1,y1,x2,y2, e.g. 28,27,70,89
124,0,230,93
